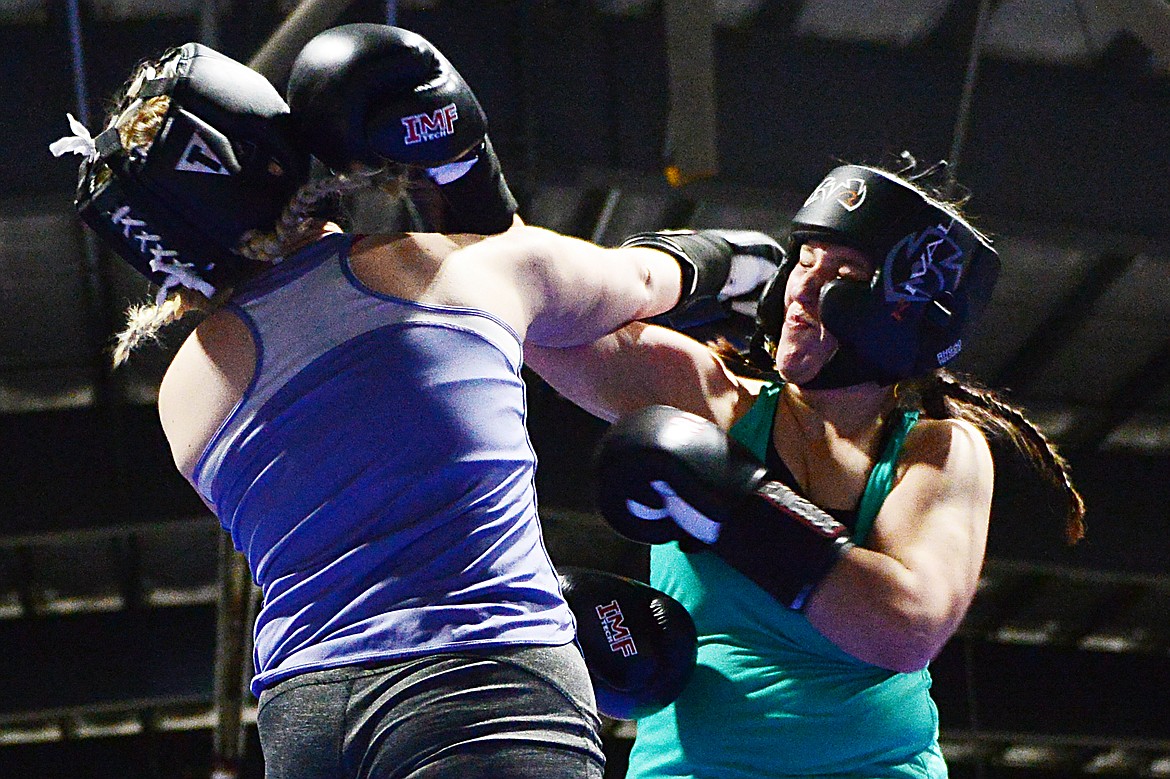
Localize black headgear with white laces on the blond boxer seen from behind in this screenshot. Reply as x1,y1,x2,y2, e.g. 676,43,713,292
54,43,309,296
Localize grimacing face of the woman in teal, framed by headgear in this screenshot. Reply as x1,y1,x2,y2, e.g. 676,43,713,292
776,241,874,385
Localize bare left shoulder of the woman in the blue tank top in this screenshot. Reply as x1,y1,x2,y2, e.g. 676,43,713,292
158,310,256,477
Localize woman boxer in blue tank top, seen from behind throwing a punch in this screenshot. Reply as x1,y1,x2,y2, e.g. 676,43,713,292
53,25,767,779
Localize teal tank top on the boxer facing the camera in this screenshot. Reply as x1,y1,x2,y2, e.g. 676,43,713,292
627,384,947,779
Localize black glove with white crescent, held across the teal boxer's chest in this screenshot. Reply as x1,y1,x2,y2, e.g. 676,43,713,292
597,406,853,611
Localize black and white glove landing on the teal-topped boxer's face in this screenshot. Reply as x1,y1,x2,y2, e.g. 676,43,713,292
621,229,784,330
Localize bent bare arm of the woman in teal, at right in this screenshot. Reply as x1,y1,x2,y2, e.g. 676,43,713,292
805,420,993,671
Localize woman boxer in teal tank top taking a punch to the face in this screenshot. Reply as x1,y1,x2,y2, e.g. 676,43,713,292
525,166,1083,779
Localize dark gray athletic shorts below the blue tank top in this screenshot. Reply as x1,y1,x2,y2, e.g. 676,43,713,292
257,643,605,779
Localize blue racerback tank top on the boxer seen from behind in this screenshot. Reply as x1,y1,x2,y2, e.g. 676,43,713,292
192,235,574,695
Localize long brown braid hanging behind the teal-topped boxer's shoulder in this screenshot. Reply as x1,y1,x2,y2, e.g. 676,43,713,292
920,370,1085,544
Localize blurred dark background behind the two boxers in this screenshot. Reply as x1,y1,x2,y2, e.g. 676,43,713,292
0,0,1170,779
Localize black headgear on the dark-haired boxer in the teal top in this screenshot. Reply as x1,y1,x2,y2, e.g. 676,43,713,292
752,165,999,388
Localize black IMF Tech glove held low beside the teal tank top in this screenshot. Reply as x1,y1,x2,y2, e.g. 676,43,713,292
559,567,698,719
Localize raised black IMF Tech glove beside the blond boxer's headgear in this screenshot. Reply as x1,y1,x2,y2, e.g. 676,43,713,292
288,23,517,234
